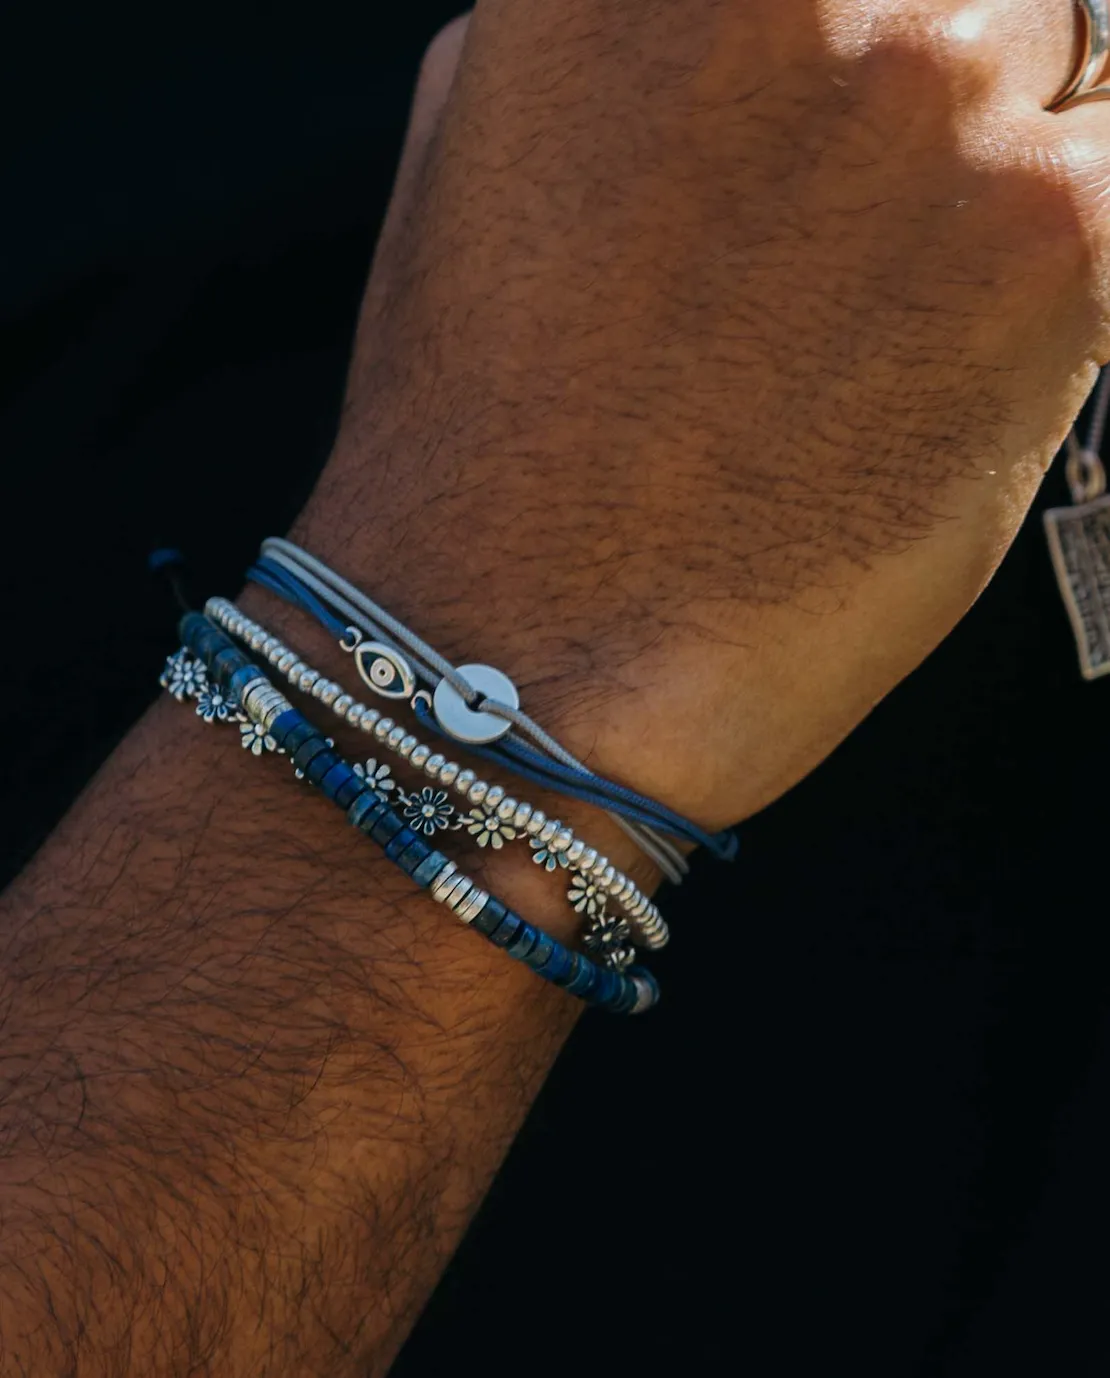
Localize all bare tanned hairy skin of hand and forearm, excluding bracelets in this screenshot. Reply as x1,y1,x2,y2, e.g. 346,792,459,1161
0,0,1110,1378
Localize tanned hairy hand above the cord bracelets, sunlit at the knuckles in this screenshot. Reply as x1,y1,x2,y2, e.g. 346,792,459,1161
296,0,1110,843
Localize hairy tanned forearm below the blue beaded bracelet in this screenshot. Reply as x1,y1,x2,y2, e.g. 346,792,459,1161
0,672,592,1375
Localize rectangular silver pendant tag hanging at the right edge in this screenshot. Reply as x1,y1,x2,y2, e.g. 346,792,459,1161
1044,496,1110,679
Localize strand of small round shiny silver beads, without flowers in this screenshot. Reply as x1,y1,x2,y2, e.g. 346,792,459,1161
204,598,671,951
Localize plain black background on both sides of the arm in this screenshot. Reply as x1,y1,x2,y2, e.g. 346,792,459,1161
0,0,1110,1378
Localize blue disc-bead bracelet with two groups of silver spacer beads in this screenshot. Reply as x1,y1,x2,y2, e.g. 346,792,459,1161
179,612,660,1014
